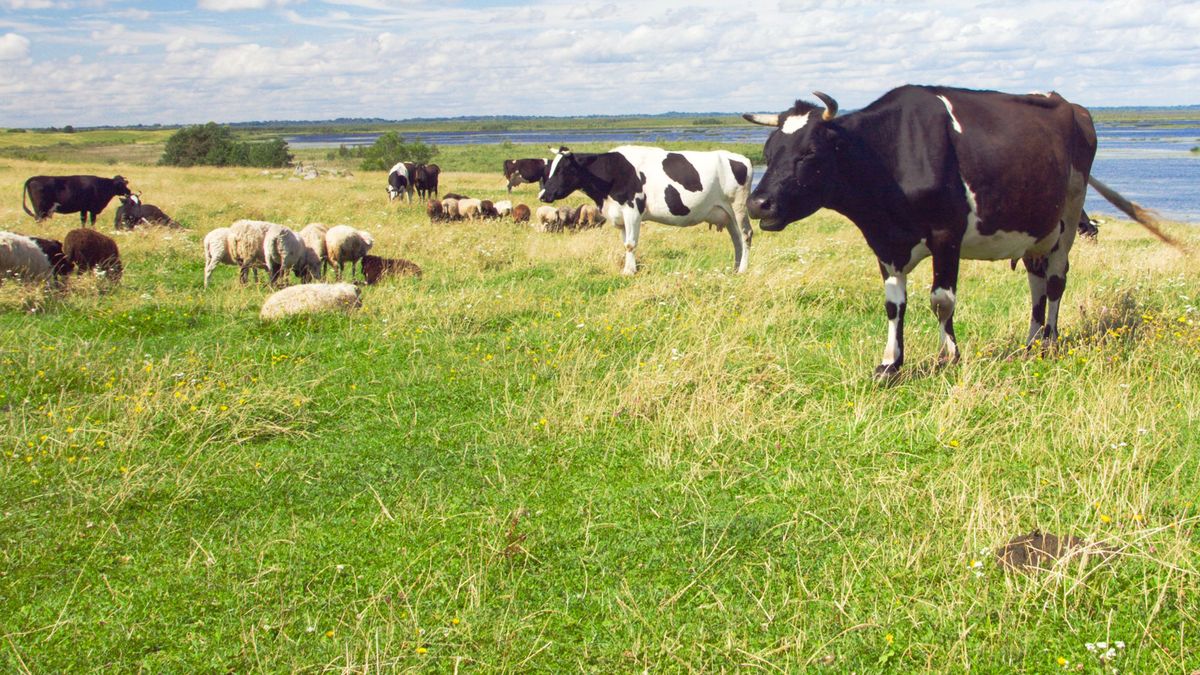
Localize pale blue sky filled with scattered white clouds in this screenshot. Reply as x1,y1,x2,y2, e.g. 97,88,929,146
0,0,1200,127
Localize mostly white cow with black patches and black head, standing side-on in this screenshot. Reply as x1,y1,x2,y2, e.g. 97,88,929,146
538,145,754,274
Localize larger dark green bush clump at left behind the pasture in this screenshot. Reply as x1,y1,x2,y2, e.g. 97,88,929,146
158,121,292,168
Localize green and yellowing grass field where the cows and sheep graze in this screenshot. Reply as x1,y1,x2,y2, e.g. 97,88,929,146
0,159,1200,673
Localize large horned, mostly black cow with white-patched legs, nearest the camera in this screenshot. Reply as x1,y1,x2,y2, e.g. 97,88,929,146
743,85,1160,377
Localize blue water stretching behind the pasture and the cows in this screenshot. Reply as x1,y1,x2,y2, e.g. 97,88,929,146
287,120,1200,223
